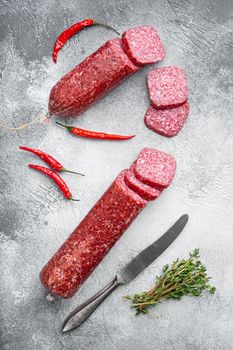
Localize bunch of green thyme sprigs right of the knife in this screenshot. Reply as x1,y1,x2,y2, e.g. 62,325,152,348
124,249,216,315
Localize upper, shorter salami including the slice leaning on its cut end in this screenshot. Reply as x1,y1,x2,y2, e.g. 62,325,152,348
49,26,165,117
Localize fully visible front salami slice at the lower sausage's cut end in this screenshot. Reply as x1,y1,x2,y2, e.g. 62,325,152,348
135,148,176,189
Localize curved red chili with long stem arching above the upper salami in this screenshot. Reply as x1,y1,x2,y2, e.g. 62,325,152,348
53,18,119,63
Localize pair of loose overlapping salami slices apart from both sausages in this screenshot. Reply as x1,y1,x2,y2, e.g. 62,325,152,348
144,66,189,137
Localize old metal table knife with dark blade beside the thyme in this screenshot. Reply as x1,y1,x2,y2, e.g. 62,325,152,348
62,214,188,332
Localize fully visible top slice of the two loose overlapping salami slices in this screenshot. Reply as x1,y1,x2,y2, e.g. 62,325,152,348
148,66,188,108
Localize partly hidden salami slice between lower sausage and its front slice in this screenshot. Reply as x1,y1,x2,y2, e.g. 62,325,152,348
125,165,162,201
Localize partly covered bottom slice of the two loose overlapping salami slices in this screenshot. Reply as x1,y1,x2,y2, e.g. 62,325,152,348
144,101,189,137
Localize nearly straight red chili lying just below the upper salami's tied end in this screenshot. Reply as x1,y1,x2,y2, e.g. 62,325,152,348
56,122,135,140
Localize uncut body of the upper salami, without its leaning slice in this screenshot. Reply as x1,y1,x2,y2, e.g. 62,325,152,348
49,39,139,117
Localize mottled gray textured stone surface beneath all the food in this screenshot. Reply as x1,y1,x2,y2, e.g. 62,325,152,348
0,0,233,350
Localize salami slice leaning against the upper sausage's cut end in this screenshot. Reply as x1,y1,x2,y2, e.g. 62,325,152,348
122,26,165,66
